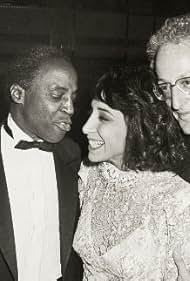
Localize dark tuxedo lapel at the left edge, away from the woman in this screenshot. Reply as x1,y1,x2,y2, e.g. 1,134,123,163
0,131,18,280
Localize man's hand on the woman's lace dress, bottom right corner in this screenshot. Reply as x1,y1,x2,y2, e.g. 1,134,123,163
173,246,190,281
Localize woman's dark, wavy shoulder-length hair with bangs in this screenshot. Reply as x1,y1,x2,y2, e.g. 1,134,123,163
93,67,186,171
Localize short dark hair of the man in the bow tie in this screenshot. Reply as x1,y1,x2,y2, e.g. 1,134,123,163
6,46,73,89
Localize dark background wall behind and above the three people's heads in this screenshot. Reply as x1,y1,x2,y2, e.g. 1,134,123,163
0,0,190,153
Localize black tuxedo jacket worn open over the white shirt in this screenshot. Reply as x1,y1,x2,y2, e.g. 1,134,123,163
0,126,82,281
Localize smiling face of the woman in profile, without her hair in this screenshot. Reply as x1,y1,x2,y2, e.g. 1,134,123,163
83,100,127,168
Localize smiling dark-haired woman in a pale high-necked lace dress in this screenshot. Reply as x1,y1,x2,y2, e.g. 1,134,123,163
74,64,190,281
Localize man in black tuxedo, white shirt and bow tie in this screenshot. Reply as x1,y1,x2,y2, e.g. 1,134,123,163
0,44,81,281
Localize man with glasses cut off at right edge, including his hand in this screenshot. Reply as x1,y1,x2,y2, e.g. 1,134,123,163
147,14,190,281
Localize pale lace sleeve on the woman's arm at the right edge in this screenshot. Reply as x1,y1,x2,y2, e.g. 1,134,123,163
164,188,190,281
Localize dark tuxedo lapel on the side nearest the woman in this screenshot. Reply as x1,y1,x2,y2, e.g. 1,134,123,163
54,150,78,275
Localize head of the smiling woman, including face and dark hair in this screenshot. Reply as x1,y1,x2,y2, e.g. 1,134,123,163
83,67,184,171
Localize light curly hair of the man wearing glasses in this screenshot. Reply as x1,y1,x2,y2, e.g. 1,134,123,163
147,13,190,68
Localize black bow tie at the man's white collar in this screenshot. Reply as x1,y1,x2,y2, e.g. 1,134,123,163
15,140,55,151
